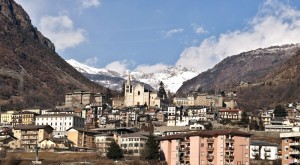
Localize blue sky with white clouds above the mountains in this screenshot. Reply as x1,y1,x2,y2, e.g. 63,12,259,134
16,0,300,72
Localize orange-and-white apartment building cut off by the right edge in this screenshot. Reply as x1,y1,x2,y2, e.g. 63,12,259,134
280,132,300,165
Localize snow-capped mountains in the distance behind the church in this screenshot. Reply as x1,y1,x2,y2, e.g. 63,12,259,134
67,59,199,93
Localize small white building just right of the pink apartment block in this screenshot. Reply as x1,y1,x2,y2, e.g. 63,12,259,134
250,141,278,160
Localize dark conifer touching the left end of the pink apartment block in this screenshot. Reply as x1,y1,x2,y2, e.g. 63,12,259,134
141,134,160,161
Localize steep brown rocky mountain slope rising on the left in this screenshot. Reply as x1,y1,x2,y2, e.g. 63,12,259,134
0,0,106,109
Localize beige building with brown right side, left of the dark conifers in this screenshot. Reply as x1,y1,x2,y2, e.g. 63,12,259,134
67,128,98,148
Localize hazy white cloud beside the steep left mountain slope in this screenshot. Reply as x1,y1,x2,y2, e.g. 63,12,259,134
38,15,86,51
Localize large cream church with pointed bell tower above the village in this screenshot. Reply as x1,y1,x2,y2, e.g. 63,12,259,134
124,73,160,107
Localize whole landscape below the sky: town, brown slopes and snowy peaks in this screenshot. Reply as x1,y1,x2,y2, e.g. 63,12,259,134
0,0,300,165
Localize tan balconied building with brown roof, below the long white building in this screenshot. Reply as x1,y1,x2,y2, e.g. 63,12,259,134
13,125,53,150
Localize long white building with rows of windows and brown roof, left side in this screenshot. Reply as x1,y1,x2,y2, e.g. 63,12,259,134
35,114,84,137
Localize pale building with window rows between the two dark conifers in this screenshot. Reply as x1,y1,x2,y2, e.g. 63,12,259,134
118,132,149,156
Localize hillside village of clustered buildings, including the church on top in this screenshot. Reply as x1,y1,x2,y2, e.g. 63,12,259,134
0,75,300,165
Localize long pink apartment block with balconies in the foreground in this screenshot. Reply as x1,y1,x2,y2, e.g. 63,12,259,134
160,129,251,165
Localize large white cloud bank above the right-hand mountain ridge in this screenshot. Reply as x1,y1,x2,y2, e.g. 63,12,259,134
176,0,300,71
